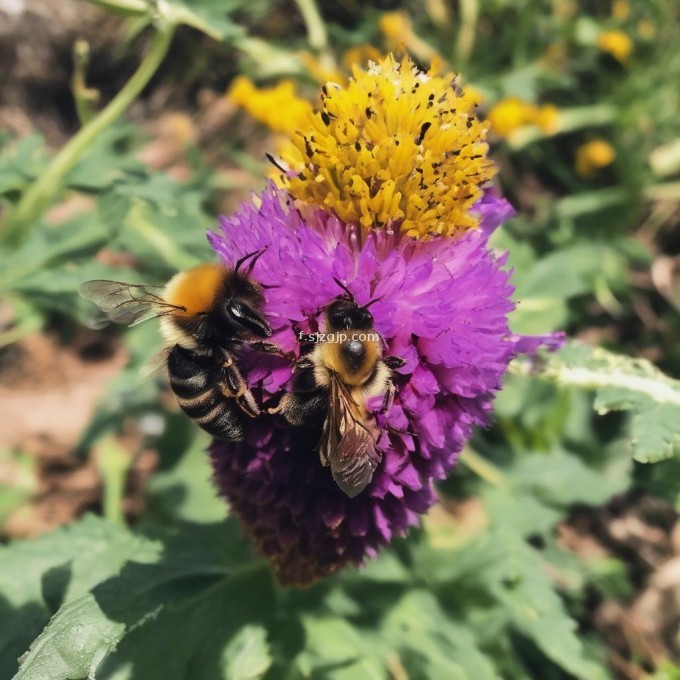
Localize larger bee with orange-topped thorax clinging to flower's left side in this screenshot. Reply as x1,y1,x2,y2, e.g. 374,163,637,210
79,250,280,441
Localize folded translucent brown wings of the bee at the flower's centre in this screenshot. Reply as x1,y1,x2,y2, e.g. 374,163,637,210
321,376,381,498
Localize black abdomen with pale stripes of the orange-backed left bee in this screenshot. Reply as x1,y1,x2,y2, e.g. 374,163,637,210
168,345,245,440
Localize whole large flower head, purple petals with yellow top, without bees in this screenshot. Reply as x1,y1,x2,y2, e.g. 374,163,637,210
209,57,561,586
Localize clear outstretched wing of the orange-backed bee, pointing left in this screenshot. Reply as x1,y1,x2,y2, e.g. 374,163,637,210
78,280,186,326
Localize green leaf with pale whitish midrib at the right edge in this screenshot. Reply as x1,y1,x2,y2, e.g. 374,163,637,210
511,342,680,463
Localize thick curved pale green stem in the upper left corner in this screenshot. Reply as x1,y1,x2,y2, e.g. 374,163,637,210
0,24,175,245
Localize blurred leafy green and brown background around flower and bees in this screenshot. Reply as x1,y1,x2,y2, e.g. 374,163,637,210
0,0,680,680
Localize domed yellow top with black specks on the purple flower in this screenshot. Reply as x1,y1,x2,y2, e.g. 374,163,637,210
279,55,495,238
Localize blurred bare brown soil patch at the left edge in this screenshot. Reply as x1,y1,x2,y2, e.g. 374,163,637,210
0,329,155,538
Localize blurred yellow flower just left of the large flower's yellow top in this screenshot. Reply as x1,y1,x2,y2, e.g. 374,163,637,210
227,76,312,133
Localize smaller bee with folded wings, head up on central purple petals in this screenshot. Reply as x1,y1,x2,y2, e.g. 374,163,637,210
270,279,405,498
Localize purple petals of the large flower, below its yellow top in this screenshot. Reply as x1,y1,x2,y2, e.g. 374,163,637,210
209,186,559,585
